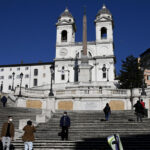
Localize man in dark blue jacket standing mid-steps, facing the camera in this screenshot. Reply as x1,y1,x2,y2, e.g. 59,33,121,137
60,112,70,140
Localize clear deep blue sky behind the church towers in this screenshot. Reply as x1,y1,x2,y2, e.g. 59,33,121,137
0,0,150,72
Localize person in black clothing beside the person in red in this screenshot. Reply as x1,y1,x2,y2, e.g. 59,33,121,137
133,100,144,122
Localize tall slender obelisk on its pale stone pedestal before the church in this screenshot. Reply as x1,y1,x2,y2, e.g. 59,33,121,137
79,7,92,83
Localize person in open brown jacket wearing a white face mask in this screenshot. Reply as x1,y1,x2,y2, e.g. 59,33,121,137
0,116,15,150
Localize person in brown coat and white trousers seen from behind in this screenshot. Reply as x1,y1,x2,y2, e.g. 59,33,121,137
22,120,36,150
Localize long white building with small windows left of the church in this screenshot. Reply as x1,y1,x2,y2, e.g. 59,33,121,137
0,62,52,93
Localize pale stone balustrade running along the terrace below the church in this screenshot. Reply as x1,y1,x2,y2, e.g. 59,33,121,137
15,87,150,98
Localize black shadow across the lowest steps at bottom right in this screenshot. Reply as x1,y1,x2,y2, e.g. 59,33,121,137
75,134,150,150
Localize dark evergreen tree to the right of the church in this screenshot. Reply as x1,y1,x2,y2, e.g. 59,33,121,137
119,55,143,89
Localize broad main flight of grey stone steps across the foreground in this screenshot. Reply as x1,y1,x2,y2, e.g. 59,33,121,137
11,111,150,150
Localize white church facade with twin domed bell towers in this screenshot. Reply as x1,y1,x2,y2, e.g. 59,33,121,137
55,5,115,85
